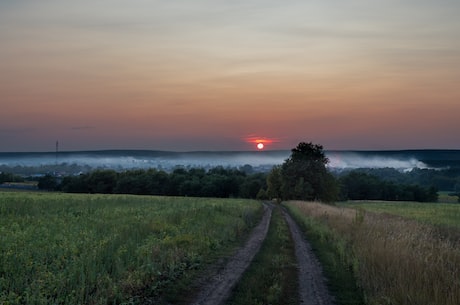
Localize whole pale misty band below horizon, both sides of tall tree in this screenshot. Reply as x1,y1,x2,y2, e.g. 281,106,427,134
0,150,460,172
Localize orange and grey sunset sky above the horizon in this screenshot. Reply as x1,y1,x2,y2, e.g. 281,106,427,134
0,0,460,151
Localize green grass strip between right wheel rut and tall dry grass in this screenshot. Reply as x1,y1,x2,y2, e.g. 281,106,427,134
283,202,364,305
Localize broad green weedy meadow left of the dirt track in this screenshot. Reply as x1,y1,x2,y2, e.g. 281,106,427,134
0,192,263,304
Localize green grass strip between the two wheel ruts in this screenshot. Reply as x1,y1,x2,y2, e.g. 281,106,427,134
226,207,299,305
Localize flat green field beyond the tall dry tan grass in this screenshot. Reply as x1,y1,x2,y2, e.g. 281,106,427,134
340,201,460,228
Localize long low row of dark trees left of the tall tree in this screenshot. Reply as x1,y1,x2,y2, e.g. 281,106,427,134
39,167,266,199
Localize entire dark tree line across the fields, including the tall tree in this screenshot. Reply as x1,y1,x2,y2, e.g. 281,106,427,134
32,142,450,202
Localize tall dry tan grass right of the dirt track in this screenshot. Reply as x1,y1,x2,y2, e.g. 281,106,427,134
287,202,460,305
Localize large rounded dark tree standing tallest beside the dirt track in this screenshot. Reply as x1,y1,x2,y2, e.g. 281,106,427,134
267,142,339,202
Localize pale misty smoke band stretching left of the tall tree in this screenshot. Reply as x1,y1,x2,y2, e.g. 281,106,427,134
0,151,289,170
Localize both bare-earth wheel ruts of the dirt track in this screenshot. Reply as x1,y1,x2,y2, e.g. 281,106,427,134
191,204,334,305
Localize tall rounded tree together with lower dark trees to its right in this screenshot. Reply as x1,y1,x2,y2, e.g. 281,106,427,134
267,143,438,202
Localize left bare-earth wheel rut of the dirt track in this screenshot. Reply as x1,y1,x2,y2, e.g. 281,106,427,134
192,204,273,305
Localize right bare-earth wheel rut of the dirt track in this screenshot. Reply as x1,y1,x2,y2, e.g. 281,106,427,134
282,208,334,305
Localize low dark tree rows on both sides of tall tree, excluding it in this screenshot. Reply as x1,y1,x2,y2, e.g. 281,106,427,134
23,167,460,202
